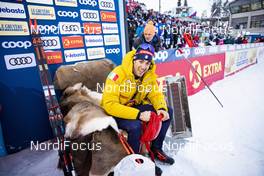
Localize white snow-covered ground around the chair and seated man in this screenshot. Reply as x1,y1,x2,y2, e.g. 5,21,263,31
0,58,264,176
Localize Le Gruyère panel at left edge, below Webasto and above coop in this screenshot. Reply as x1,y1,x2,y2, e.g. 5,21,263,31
0,21,29,36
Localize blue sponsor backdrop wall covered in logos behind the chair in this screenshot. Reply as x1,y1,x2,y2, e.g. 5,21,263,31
0,0,126,153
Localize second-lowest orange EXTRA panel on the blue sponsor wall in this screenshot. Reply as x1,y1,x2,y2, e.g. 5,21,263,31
62,36,84,48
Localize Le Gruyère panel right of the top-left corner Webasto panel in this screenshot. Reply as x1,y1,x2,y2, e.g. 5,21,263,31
28,5,56,20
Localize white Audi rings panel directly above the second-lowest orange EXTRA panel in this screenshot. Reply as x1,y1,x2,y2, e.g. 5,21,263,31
59,22,81,34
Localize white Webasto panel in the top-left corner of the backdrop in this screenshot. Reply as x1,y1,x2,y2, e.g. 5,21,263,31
0,2,26,18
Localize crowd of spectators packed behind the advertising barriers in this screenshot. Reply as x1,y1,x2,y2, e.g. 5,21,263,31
127,4,264,49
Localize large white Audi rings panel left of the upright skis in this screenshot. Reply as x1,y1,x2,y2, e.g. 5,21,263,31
4,53,36,70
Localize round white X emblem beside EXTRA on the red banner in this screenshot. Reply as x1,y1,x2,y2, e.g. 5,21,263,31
189,60,202,89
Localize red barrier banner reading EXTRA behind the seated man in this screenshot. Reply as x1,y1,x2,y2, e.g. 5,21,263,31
156,54,225,95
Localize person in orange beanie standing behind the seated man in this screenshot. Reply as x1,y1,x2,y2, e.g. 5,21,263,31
133,21,161,52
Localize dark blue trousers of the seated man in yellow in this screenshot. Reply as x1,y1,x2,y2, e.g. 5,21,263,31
115,104,173,153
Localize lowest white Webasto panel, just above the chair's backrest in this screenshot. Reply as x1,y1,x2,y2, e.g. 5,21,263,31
64,49,86,62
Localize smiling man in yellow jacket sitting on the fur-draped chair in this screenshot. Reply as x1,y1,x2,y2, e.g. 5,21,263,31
101,43,174,175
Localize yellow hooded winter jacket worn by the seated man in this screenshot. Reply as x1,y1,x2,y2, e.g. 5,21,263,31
101,50,167,119
